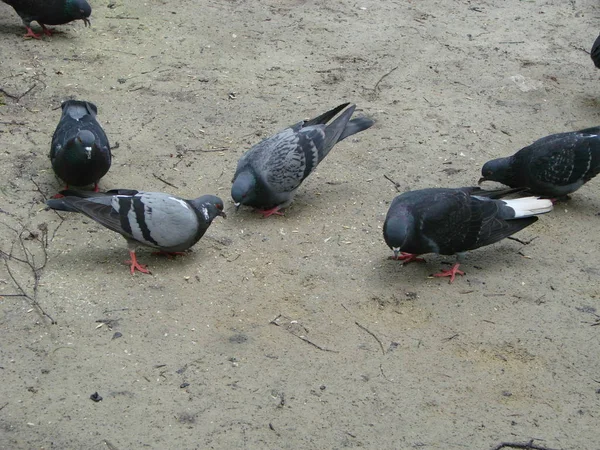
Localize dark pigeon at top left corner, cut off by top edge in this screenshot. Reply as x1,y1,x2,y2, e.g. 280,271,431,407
2,0,92,39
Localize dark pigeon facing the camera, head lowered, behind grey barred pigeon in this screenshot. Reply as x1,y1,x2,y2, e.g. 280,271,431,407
50,100,111,191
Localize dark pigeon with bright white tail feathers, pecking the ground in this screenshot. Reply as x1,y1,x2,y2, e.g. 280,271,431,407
383,187,552,283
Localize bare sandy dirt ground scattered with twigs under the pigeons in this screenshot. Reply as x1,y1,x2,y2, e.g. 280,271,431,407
0,0,600,450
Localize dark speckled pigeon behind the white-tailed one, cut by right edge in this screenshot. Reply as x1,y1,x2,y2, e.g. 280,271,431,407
479,127,600,197
